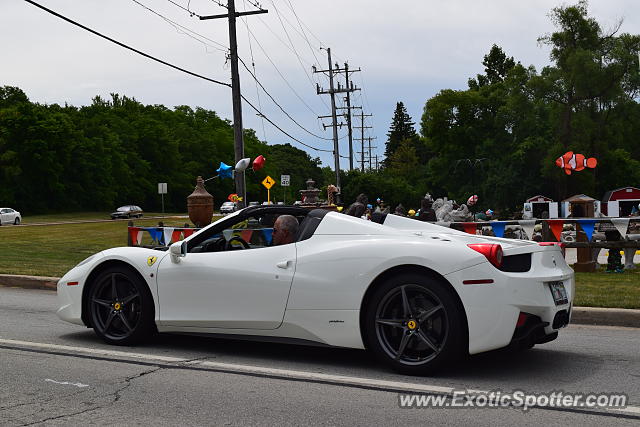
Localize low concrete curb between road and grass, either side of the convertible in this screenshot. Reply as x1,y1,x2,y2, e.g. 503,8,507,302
0,274,640,328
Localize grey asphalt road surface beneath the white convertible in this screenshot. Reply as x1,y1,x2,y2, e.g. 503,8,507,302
0,287,640,426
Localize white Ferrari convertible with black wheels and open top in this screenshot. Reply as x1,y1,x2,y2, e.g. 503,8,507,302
58,206,575,374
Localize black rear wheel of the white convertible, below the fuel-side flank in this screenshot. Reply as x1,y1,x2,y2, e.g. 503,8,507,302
363,274,464,375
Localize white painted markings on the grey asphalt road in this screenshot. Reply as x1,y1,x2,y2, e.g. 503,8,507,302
0,338,640,415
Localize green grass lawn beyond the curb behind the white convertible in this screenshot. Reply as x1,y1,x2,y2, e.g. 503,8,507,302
0,212,640,309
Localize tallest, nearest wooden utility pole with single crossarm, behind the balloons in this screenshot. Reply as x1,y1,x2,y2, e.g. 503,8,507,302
200,0,268,208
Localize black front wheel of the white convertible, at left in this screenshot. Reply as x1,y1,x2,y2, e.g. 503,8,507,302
87,267,155,345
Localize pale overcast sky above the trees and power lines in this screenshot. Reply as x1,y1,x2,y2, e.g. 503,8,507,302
0,0,640,169
